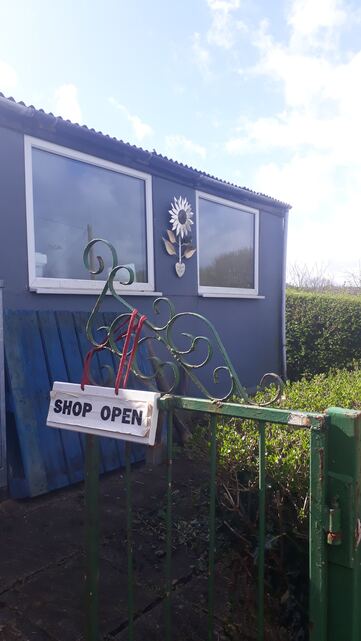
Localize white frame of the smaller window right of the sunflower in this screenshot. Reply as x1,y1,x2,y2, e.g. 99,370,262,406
196,191,258,298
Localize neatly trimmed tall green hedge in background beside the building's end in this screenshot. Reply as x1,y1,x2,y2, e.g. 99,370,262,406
286,289,361,380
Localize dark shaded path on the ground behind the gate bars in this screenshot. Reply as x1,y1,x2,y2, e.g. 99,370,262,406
0,460,229,641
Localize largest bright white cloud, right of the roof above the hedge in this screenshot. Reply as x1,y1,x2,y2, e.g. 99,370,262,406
225,0,361,282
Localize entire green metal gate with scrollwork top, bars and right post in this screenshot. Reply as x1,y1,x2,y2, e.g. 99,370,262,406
80,239,361,641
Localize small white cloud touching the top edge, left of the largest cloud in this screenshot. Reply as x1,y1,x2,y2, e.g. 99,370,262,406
207,0,246,49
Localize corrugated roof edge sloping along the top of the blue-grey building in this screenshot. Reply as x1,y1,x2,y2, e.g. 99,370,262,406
0,91,291,209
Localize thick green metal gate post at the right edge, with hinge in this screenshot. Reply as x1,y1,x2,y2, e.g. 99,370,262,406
324,407,361,641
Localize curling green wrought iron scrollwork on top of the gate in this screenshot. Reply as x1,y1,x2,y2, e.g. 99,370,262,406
84,238,283,406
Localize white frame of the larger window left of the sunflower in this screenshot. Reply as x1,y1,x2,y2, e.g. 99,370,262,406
24,136,155,295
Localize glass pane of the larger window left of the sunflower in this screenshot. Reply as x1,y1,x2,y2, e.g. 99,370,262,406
32,148,148,283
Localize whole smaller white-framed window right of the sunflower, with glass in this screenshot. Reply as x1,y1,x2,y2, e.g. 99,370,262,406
197,193,259,296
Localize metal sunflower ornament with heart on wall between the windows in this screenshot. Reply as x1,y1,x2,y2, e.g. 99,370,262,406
163,196,197,278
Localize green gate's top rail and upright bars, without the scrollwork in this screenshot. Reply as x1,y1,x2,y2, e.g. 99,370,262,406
82,395,332,641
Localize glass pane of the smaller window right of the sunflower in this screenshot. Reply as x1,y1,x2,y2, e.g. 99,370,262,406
199,198,255,289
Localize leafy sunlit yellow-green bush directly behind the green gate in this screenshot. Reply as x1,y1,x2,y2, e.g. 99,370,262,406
187,369,361,510
